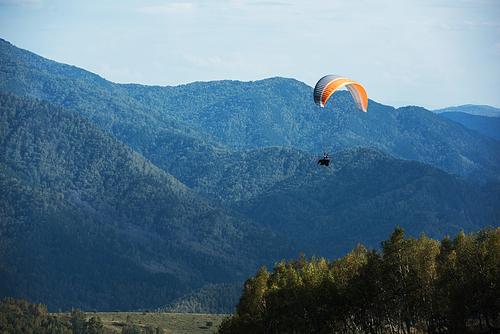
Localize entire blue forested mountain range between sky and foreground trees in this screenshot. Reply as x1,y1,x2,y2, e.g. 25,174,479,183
0,40,500,311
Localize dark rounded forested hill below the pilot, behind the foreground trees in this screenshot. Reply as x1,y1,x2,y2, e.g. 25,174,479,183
233,147,494,258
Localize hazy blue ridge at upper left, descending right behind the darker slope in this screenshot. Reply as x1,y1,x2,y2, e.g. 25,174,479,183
0,40,225,153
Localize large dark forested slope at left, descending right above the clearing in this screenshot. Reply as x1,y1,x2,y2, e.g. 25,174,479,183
0,93,308,311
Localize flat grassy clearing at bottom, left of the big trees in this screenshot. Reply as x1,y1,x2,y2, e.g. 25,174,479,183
75,312,226,334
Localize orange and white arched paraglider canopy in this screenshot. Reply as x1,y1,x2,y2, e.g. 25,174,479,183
314,75,368,112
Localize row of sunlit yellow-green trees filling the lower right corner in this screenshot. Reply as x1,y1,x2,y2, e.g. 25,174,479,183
219,227,500,334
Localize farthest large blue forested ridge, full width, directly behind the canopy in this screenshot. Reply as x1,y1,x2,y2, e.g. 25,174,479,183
0,41,500,182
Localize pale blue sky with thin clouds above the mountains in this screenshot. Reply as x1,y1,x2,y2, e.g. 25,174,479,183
0,0,500,110
